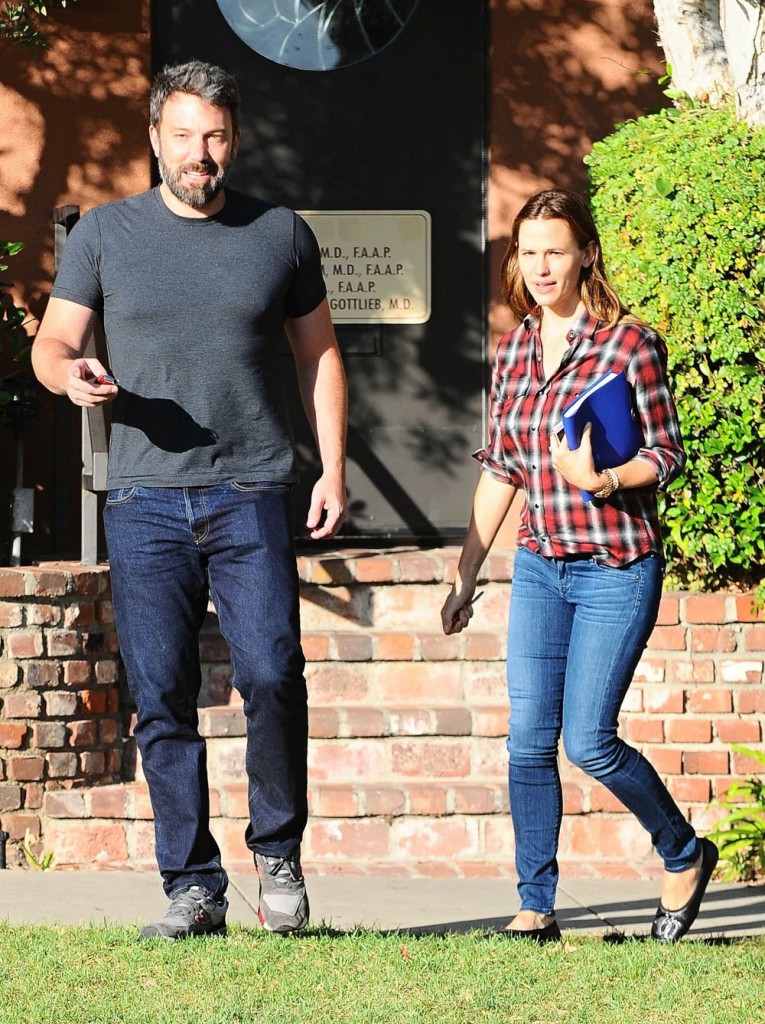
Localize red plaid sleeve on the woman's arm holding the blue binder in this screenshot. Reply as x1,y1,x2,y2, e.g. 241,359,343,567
626,331,685,490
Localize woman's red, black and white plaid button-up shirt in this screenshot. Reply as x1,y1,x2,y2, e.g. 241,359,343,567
475,313,685,565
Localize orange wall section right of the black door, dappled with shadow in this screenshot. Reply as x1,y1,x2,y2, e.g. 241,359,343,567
490,0,666,341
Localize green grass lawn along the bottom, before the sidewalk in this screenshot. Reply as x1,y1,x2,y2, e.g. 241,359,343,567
0,926,765,1024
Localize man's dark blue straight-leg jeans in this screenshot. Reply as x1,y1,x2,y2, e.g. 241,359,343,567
104,483,308,895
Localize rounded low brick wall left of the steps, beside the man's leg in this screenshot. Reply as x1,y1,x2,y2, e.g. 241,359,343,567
0,563,122,865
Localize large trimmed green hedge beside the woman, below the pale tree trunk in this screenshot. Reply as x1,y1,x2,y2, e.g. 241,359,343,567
586,109,765,589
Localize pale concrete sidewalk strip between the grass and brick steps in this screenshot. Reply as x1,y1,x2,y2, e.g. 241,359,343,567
0,870,765,939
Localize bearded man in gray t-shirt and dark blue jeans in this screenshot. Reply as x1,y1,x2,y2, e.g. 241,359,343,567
33,61,346,939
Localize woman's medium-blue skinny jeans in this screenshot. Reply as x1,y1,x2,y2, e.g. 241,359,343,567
507,548,698,914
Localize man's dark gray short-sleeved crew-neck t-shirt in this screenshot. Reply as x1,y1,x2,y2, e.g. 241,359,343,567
52,188,326,487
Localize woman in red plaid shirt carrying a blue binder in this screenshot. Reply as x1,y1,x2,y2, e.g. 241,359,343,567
441,189,718,942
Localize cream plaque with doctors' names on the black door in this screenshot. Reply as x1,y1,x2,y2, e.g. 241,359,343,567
300,210,430,324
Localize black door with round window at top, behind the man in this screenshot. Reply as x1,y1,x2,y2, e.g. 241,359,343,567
153,0,486,540
